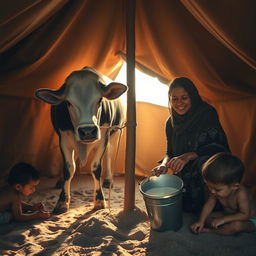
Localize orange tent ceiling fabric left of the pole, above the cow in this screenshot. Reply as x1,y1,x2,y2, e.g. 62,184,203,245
0,1,124,97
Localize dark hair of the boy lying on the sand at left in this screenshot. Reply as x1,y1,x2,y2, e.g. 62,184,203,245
8,163,40,186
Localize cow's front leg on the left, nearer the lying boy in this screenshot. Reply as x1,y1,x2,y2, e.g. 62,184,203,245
54,150,76,214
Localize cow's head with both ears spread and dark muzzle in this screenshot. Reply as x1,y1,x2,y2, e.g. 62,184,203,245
35,67,127,143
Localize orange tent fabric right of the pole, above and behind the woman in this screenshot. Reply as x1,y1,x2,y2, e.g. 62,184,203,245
136,0,256,184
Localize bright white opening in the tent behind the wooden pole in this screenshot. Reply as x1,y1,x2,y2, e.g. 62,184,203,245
115,62,168,107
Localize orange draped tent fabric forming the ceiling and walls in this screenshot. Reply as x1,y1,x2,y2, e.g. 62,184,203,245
0,0,256,192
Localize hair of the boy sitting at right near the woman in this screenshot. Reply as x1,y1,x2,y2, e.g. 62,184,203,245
202,152,244,185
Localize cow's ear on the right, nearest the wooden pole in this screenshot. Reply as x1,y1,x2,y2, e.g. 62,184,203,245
101,82,128,100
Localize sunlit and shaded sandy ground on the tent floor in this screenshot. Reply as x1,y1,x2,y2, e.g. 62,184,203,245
0,174,256,256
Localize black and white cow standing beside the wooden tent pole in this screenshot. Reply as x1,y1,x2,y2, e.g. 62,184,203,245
35,67,127,213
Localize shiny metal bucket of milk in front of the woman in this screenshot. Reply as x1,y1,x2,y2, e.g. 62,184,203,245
139,174,183,231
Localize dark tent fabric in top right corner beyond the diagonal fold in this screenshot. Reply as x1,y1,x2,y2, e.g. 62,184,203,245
181,0,256,69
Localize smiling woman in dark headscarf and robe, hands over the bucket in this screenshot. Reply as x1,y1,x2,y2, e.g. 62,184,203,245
152,77,229,212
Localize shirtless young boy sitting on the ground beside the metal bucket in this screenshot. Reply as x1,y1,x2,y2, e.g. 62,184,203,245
191,153,256,235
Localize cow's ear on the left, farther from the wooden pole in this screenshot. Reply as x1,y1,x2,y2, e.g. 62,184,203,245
35,89,64,105
